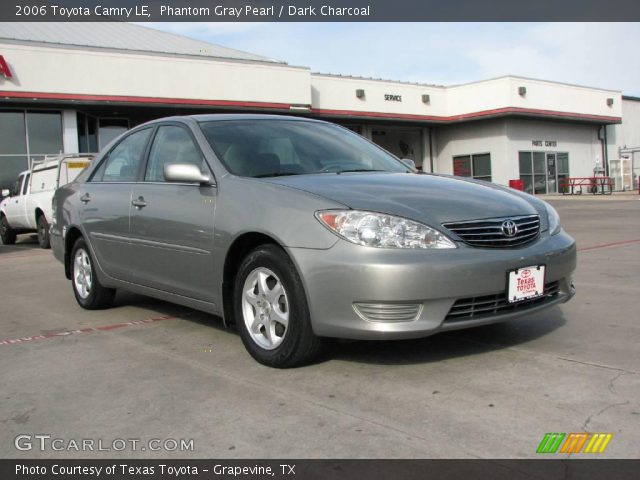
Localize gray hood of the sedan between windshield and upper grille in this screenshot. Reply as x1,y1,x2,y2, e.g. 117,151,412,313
265,173,544,225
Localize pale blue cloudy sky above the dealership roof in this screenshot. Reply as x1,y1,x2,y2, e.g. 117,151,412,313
145,22,640,96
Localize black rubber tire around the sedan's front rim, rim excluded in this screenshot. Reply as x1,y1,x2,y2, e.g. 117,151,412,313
233,245,313,368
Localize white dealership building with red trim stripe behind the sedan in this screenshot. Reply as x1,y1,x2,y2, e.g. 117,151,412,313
0,23,640,194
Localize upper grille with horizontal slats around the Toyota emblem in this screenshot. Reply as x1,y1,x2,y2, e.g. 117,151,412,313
442,215,540,248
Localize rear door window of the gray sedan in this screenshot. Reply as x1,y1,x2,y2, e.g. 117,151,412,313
91,128,151,182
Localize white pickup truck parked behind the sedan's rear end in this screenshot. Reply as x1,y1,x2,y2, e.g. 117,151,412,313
0,155,92,248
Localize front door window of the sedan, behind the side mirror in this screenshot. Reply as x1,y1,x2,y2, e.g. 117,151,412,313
144,125,204,182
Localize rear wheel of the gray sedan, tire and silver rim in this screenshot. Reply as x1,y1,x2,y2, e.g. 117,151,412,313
69,237,116,310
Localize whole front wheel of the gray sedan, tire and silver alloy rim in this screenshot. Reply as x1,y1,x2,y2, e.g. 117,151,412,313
234,245,324,368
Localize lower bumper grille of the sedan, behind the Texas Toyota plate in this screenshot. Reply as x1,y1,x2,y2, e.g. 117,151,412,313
444,281,560,323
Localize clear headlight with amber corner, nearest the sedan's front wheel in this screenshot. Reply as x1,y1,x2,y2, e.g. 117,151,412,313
316,210,457,249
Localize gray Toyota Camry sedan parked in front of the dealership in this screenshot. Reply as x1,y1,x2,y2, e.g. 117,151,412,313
51,115,576,367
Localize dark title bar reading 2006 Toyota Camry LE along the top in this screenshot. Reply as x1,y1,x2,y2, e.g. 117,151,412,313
0,0,640,22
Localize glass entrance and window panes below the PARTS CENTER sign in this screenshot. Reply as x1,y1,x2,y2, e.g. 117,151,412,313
518,152,569,194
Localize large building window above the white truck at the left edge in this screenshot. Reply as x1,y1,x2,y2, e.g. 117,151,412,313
0,110,63,188
